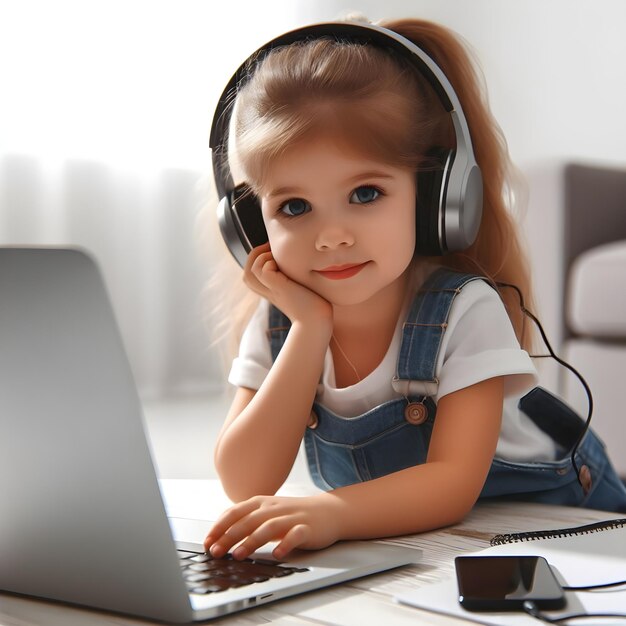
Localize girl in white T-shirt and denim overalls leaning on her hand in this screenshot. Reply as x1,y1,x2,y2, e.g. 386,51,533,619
205,20,626,559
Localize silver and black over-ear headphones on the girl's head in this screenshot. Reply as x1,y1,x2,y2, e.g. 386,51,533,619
210,22,483,267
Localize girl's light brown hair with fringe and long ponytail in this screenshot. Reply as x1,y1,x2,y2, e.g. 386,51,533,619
206,19,532,356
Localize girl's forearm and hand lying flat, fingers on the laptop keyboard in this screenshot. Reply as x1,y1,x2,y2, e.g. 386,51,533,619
205,462,480,559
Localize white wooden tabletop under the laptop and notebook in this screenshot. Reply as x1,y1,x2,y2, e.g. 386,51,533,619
0,479,615,626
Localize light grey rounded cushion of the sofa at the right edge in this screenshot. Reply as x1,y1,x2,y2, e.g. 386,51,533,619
566,241,626,338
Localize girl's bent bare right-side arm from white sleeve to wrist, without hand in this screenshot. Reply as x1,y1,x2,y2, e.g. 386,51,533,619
327,378,503,539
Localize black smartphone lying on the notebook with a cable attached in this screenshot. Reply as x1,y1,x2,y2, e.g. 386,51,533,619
454,556,565,611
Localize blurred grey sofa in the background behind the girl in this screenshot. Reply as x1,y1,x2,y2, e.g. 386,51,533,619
560,164,626,477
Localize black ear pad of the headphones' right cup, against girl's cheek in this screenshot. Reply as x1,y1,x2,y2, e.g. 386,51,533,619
415,148,454,256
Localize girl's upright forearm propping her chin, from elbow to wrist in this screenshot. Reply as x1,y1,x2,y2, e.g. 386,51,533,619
215,322,331,500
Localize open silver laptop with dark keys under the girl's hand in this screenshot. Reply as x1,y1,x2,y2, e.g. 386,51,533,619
0,247,419,623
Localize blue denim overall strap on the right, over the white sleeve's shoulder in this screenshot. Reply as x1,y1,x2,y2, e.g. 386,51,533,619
392,268,486,397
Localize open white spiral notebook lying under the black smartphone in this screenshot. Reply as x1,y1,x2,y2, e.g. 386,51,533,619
396,518,626,626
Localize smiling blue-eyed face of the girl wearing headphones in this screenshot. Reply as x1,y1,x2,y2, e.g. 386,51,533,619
261,139,415,305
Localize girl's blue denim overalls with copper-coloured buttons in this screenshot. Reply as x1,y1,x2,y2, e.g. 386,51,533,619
268,268,626,512
